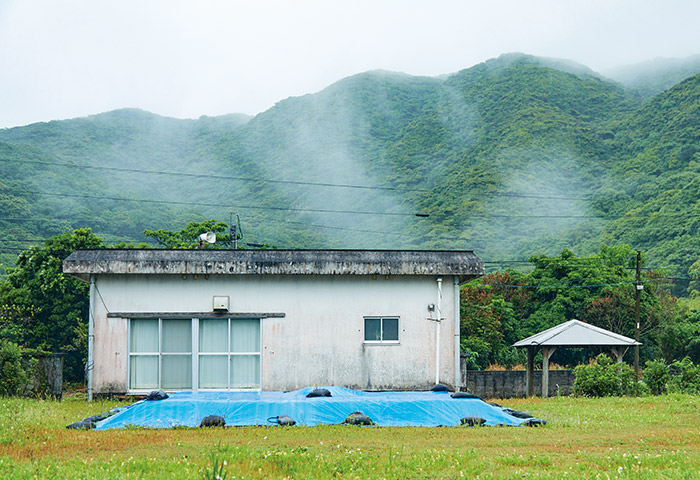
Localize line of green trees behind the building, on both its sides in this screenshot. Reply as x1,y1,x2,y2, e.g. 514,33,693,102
0,226,700,382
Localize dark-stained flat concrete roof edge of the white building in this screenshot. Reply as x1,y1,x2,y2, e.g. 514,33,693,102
63,249,484,283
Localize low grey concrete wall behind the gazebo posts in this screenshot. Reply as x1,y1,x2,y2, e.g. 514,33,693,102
462,364,574,398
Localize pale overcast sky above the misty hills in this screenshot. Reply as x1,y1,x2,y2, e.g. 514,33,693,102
0,0,700,128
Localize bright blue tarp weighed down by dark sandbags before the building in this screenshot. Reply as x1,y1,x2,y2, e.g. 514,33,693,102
96,387,523,430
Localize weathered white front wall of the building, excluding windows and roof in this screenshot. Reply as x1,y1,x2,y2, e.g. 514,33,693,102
93,275,454,393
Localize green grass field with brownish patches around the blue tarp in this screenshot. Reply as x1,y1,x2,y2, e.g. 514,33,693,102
0,395,700,480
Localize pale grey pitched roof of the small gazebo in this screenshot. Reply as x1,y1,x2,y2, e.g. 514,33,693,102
513,320,641,348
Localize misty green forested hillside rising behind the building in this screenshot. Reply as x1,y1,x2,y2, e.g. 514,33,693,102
0,54,700,293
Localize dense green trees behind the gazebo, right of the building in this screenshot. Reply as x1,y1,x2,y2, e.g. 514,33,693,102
461,245,688,368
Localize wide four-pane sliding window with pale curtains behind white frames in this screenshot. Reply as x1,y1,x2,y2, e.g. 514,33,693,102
129,318,260,390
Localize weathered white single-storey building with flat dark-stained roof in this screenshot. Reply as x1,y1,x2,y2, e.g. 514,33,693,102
63,250,484,397
